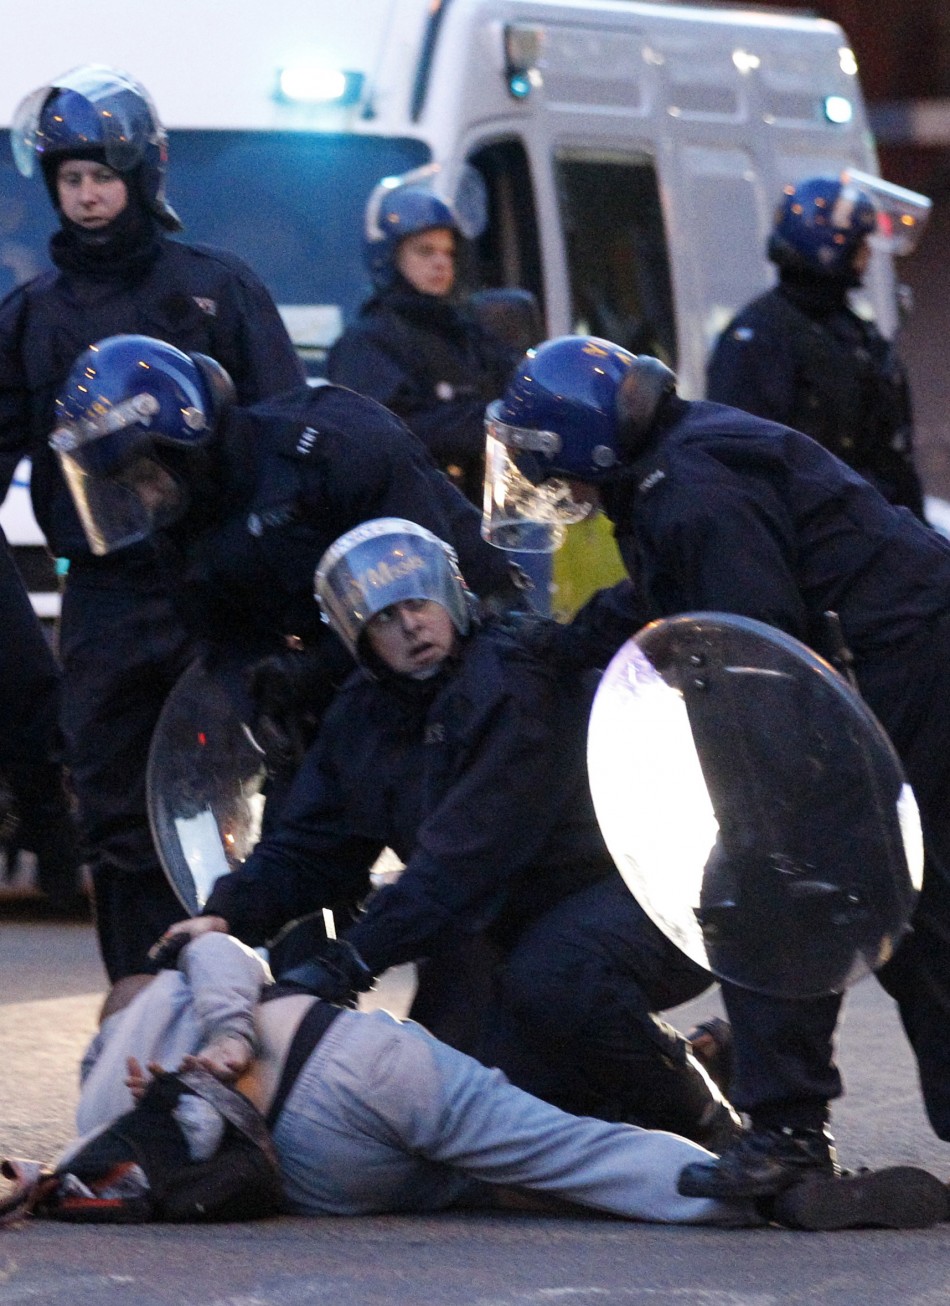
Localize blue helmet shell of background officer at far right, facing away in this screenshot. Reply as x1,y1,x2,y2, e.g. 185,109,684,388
768,176,878,285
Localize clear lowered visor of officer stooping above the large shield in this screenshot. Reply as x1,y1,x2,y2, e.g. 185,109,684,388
482,404,591,554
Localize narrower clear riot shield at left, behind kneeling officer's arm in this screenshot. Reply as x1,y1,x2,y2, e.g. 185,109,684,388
146,661,265,916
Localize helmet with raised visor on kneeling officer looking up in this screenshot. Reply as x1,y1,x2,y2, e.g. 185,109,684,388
314,517,474,670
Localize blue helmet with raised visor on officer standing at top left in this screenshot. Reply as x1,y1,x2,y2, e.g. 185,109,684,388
10,64,182,231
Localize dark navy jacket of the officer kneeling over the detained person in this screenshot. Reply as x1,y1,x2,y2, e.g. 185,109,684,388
204,627,617,973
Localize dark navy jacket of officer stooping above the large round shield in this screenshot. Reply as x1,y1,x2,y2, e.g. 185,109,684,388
565,398,950,705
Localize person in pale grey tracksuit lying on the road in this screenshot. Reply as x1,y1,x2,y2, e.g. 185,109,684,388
65,934,946,1228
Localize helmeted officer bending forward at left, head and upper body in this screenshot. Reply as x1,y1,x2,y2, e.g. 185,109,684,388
51,336,523,688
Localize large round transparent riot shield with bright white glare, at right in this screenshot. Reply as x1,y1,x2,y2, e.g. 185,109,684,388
588,613,923,998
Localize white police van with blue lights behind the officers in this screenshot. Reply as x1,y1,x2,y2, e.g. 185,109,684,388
0,0,896,616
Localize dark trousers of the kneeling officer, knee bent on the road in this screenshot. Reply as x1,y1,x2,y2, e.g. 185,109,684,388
481,875,712,1136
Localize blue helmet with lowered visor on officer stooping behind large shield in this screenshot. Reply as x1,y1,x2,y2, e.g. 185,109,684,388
482,336,676,552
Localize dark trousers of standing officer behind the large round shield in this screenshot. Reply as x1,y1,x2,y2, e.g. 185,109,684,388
723,618,950,1141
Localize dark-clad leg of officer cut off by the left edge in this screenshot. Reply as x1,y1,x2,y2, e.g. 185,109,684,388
0,530,81,916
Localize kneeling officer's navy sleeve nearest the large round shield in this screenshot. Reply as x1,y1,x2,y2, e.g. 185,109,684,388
345,647,595,974
